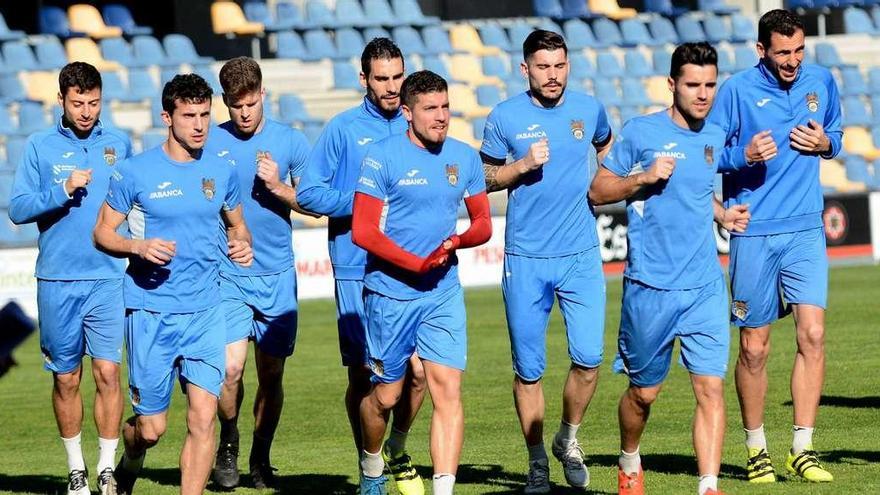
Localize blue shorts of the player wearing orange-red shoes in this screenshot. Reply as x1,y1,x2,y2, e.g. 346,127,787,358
614,277,730,387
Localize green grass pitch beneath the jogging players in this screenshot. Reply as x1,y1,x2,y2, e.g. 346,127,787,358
0,266,880,495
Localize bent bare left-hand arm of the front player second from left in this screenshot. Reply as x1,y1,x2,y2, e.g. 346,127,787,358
92,203,177,265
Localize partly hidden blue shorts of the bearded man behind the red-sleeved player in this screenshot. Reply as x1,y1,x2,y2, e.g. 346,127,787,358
336,280,369,366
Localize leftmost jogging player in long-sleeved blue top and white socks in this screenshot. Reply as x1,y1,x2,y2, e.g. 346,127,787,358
9,62,131,495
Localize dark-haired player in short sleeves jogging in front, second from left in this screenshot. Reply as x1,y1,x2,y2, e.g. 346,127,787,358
94,74,253,494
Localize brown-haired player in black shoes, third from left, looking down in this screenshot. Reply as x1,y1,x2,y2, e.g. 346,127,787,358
205,57,309,488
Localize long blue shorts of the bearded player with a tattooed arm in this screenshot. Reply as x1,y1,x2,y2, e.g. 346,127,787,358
501,247,605,381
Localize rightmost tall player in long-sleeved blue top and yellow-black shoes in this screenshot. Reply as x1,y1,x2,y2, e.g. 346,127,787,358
710,10,843,483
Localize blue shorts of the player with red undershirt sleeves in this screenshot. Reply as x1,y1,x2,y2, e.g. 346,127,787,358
365,286,467,383
